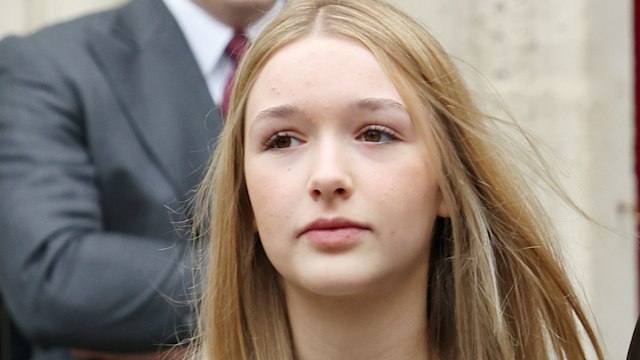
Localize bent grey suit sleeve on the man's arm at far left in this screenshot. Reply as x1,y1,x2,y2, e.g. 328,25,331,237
0,38,198,352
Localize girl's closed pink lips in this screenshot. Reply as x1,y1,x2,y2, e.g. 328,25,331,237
298,218,370,249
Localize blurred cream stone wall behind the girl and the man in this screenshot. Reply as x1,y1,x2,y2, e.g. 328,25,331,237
0,0,640,359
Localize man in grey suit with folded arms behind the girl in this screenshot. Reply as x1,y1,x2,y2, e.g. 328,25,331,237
0,0,274,360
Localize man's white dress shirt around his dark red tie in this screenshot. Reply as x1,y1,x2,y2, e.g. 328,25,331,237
163,0,283,106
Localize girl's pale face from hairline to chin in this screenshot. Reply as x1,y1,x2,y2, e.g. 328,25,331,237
244,35,446,296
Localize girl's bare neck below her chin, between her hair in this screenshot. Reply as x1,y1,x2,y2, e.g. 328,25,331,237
285,277,427,360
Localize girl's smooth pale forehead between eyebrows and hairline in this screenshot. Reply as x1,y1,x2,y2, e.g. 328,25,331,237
247,35,402,114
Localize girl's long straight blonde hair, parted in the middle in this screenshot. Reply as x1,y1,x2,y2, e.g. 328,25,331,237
194,0,603,360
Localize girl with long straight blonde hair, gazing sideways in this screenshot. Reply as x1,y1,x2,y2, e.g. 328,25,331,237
191,0,603,360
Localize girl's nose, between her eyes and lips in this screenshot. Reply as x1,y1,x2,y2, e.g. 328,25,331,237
307,144,353,201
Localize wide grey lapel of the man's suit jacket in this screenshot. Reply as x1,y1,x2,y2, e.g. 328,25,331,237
91,0,222,197
